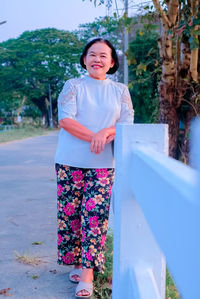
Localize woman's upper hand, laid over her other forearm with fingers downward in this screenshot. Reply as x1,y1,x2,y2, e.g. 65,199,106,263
90,128,109,154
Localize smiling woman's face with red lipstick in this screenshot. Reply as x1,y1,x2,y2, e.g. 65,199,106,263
83,42,114,80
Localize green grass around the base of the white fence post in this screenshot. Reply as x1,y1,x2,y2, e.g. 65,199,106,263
94,232,180,299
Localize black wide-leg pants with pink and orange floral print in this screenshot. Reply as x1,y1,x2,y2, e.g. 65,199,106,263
56,164,114,273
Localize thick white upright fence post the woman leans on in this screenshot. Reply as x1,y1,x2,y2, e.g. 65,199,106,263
113,124,168,299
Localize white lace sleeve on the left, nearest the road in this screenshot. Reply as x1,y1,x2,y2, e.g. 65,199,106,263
58,80,77,120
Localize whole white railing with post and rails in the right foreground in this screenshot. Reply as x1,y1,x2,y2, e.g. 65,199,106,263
113,120,200,299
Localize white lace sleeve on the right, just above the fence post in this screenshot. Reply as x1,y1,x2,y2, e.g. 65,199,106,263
117,86,134,124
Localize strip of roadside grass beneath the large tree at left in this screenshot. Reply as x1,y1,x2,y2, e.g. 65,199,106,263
0,126,55,143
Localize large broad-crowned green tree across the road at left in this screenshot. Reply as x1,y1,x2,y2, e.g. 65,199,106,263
0,29,83,125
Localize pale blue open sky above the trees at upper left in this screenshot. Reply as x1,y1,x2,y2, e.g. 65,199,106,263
0,0,106,42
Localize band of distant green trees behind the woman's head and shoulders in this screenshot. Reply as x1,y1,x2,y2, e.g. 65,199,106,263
0,17,158,126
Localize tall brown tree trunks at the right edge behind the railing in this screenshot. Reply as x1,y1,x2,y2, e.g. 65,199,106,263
153,0,200,162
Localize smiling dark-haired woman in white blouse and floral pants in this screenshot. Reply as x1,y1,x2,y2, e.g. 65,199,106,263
55,38,133,298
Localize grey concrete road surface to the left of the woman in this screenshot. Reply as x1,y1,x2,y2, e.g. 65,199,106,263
0,133,75,299
